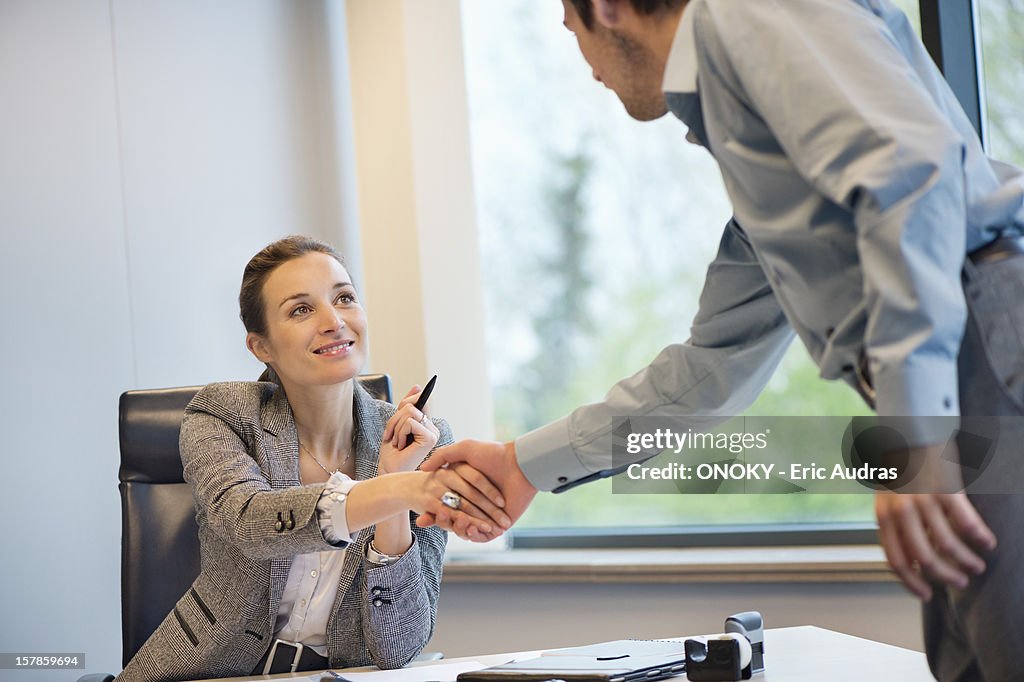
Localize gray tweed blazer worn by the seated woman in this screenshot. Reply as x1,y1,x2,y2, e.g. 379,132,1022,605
118,382,452,682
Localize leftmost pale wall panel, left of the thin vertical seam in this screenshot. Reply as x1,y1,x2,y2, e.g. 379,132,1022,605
0,1,135,679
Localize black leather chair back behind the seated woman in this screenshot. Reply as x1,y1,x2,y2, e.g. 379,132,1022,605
118,374,391,665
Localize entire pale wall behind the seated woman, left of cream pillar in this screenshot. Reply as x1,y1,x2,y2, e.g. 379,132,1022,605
0,0,358,680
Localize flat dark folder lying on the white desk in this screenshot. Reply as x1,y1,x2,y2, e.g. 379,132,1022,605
458,639,686,682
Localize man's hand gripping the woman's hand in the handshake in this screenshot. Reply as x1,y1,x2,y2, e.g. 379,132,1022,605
416,440,537,542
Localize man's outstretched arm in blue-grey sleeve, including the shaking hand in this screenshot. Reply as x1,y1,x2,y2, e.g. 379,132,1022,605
423,221,793,531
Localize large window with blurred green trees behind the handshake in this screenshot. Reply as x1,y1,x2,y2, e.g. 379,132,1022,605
462,0,920,529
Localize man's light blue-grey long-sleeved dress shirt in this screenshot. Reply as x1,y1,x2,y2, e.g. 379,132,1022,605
516,0,1024,489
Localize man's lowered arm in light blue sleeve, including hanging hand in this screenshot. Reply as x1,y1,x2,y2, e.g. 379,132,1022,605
695,0,995,599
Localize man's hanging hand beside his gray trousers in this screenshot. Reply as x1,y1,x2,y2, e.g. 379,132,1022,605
874,492,995,601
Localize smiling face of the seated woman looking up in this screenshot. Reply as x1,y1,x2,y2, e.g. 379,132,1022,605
246,252,367,386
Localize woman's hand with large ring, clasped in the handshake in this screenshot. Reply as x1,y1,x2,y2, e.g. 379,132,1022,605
399,465,512,540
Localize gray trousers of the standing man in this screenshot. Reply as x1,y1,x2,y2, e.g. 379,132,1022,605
924,250,1024,682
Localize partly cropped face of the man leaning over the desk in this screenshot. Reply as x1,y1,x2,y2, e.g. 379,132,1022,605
562,0,668,121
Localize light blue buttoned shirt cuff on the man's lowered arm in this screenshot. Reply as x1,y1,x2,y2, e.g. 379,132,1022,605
871,358,959,447
